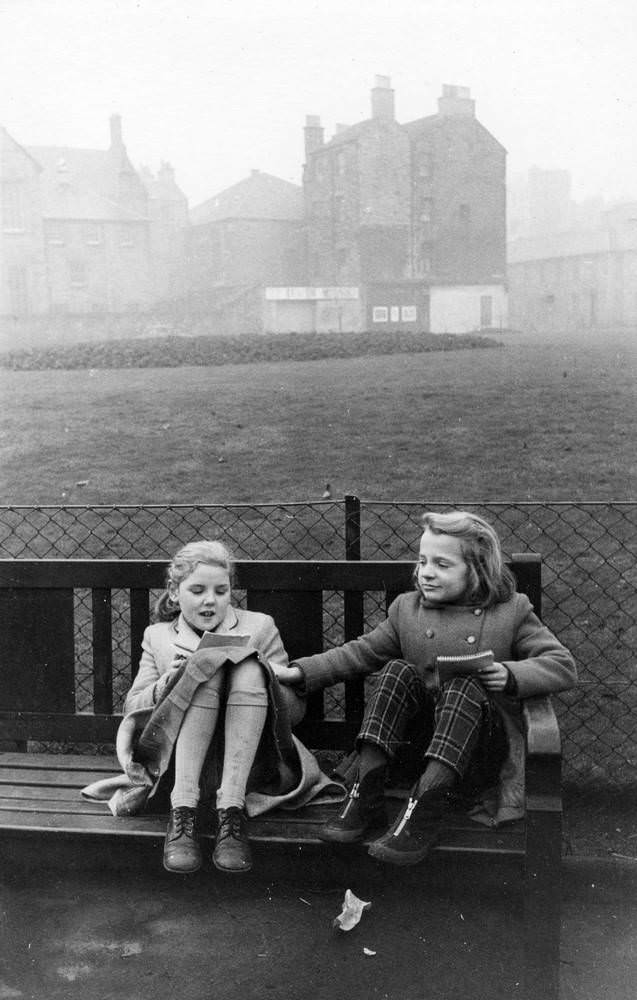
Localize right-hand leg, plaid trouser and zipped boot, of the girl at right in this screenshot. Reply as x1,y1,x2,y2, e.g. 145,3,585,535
369,678,488,865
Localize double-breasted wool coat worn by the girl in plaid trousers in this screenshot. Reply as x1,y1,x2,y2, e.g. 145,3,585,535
293,591,577,819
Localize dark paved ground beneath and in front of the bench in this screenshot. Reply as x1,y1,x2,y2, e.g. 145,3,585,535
0,848,637,1000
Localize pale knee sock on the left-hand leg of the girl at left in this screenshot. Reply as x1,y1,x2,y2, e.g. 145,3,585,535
170,684,219,809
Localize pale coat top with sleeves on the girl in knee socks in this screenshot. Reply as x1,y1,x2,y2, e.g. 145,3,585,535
124,606,305,726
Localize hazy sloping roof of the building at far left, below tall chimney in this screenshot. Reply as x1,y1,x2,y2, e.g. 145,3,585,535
28,146,147,222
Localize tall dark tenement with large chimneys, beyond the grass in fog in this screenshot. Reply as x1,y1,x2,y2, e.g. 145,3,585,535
303,77,506,332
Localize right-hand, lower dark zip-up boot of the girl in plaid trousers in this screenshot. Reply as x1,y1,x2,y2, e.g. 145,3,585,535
369,786,452,865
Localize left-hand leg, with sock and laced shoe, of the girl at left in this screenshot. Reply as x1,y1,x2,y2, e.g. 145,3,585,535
164,671,223,873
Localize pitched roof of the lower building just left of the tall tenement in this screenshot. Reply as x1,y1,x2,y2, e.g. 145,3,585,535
190,170,303,226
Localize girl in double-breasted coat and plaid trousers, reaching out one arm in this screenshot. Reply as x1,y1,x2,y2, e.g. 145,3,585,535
281,511,576,865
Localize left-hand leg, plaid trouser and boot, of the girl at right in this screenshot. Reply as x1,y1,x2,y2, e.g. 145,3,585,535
319,660,426,844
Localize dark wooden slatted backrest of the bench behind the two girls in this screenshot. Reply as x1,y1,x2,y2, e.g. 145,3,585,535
0,553,541,747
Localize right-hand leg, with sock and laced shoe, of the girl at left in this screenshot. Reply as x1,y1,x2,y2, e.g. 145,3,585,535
212,659,268,871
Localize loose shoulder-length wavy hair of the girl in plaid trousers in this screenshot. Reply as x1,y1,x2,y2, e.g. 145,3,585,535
421,510,516,608
